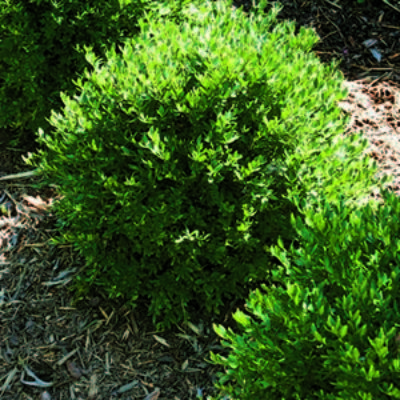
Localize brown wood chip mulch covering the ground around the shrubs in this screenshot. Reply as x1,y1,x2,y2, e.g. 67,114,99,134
0,0,400,400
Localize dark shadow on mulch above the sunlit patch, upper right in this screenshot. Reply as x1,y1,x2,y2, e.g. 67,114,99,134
241,0,400,83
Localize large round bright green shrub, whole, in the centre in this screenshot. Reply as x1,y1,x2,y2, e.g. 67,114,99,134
23,2,386,326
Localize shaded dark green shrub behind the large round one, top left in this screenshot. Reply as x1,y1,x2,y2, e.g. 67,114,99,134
0,0,200,146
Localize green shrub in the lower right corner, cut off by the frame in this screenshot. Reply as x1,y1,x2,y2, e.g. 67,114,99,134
211,190,400,400
